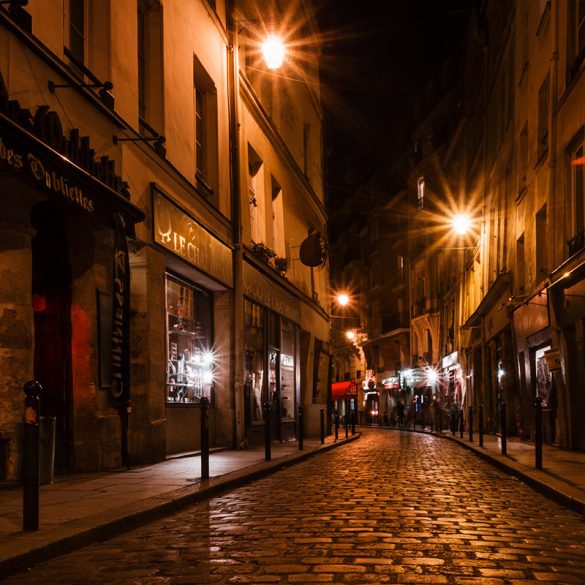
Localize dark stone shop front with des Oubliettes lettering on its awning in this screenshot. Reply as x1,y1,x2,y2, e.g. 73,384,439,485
0,75,144,480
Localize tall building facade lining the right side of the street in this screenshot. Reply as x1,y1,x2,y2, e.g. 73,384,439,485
410,0,584,450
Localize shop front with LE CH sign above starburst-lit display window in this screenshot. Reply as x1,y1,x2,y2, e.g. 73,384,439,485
152,185,232,455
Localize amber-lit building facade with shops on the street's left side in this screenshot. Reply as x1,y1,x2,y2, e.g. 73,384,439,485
0,0,329,481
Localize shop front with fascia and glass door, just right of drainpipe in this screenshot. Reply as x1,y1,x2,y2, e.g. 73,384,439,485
243,263,301,444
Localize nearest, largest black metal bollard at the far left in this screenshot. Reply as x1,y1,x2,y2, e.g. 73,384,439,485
22,380,43,530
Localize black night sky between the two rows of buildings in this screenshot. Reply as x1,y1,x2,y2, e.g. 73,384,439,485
317,0,473,205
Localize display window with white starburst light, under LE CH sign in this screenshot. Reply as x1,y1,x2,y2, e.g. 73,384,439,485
166,275,214,404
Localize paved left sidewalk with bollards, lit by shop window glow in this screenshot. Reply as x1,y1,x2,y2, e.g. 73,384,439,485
0,431,360,580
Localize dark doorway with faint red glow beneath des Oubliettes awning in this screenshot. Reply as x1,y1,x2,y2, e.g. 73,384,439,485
31,203,71,469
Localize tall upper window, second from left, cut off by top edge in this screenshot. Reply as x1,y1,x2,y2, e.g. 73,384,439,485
137,0,163,136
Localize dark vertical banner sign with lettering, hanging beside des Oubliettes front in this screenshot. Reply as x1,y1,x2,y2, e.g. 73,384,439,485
112,213,130,410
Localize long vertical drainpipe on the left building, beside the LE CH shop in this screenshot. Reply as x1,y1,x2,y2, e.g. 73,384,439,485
227,0,246,449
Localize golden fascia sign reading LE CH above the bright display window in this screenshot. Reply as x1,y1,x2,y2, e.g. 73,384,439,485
152,188,233,286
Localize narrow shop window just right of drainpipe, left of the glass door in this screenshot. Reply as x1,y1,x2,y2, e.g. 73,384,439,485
244,300,266,424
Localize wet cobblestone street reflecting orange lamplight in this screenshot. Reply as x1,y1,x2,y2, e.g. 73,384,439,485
3,429,585,585
